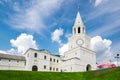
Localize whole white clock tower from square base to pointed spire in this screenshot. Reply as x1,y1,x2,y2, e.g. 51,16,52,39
62,7,96,72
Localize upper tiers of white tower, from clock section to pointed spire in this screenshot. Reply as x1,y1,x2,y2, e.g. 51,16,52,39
69,10,90,50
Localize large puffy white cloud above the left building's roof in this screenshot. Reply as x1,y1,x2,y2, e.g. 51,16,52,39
9,33,37,54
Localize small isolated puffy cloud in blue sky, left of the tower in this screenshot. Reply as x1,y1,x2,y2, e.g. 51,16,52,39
51,28,63,45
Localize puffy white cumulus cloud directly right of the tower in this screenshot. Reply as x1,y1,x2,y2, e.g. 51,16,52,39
91,36,112,62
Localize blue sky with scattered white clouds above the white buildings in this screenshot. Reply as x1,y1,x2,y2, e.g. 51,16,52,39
0,0,120,61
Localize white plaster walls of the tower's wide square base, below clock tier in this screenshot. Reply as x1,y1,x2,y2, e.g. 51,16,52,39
62,47,96,72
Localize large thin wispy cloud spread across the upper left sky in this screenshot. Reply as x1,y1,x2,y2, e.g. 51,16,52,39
7,0,62,33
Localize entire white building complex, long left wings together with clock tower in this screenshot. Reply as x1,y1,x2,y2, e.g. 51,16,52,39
0,11,96,72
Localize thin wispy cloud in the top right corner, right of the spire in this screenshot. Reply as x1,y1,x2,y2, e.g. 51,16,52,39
86,0,120,21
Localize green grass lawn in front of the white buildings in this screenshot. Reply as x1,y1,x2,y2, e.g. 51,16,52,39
0,68,120,80
